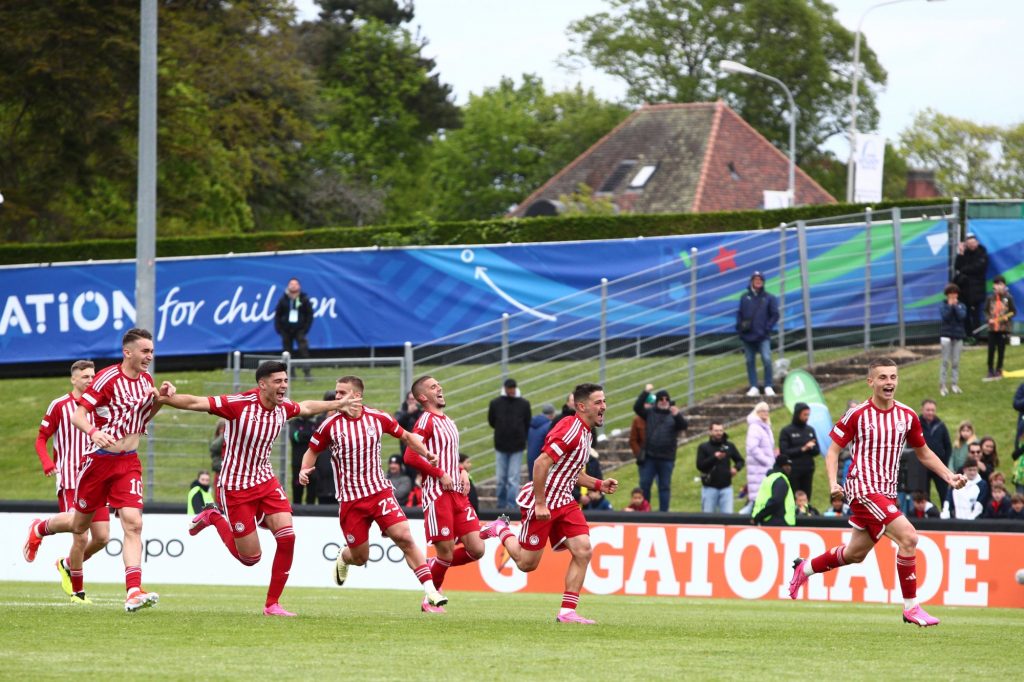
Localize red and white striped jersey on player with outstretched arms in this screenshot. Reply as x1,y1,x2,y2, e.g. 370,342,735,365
207,388,301,491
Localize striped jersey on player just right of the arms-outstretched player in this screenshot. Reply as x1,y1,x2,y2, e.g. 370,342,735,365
309,407,406,502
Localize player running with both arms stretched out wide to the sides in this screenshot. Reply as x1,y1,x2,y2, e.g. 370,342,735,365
159,360,352,615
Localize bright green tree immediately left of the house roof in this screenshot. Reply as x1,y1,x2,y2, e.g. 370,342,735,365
430,75,629,220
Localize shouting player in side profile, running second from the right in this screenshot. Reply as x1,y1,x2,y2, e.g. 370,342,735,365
480,384,618,625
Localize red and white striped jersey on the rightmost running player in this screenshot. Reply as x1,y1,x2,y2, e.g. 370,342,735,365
828,400,925,500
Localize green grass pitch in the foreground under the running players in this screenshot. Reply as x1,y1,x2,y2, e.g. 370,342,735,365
0,583,1007,681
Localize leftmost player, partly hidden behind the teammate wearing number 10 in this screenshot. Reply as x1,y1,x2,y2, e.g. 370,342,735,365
25,359,111,604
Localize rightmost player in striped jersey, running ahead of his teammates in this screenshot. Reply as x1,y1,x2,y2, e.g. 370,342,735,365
790,358,967,627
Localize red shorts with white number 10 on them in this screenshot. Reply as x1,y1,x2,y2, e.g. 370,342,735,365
75,451,144,509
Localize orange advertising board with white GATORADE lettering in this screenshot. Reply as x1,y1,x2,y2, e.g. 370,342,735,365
444,523,1024,607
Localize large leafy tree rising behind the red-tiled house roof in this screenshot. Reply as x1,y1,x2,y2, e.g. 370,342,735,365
567,0,886,159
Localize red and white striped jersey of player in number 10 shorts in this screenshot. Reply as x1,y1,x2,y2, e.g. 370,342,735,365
78,365,154,446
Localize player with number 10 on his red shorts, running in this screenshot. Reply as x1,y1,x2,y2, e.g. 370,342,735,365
24,328,165,612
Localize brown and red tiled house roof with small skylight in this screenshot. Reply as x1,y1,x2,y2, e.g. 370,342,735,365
511,100,836,217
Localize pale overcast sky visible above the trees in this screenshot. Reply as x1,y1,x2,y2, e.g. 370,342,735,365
295,0,1024,156
